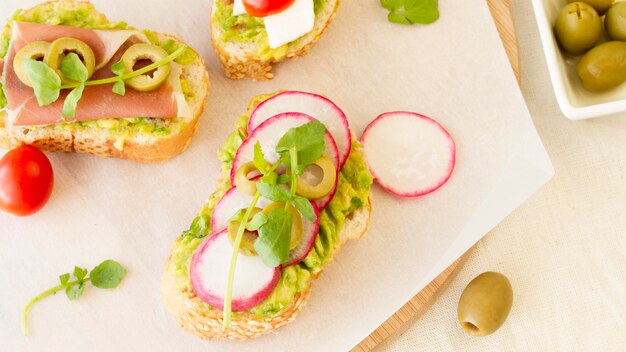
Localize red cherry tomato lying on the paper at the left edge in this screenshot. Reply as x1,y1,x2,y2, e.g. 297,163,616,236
0,145,54,216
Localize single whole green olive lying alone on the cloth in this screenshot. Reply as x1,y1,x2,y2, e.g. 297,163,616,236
458,271,513,336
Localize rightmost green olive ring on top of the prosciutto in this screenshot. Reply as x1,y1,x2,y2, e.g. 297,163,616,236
122,43,171,92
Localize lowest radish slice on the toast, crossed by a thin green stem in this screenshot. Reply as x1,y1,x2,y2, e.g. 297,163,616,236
189,230,281,312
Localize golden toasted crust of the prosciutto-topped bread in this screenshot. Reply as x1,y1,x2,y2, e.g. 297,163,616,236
0,0,210,162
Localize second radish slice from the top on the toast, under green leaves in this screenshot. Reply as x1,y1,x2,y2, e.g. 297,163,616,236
230,112,340,208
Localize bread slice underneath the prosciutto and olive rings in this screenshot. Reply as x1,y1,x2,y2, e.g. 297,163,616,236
0,0,209,162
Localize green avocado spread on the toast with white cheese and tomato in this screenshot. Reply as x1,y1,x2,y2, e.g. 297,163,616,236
213,0,324,60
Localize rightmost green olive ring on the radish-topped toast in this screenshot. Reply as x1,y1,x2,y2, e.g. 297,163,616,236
296,156,337,199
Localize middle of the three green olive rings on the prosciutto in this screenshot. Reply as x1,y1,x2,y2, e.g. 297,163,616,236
44,37,96,84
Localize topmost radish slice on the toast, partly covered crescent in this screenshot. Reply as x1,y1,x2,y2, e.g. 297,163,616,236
248,90,352,169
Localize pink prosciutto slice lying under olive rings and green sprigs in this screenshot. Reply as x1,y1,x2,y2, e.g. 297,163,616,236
3,22,190,126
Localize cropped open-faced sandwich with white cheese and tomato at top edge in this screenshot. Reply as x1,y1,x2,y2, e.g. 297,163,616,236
211,0,339,80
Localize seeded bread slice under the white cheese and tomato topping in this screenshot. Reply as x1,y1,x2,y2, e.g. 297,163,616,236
211,0,340,80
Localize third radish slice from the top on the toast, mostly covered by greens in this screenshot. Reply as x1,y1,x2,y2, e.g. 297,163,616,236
211,187,320,267
